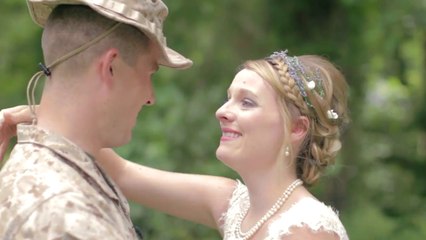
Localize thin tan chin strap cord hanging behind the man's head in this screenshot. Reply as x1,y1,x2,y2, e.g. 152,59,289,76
27,23,121,125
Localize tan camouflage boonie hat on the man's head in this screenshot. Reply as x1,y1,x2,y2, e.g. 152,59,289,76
27,0,192,69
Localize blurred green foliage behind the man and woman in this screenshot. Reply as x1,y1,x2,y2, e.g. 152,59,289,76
0,0,426,240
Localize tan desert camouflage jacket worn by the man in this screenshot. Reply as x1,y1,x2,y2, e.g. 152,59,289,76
0,125,137,240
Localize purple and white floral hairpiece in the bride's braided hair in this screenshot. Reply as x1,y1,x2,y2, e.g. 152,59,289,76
266,50,339,120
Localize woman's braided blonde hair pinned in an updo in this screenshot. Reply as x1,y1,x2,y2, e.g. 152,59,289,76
243,55,349,185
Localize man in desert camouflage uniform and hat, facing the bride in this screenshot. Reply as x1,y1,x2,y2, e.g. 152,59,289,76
0,0,192,240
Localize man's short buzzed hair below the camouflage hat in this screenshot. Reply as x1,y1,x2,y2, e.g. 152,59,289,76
42,5,149,74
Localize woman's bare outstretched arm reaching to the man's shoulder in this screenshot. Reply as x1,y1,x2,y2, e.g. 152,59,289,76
96,149,235,228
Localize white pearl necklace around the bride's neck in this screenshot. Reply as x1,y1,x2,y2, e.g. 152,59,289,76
234,179,303,240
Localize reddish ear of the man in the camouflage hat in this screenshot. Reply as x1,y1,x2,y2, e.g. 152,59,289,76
98,48,119,84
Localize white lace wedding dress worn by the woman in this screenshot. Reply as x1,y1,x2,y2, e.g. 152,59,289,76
222,181,349,240
